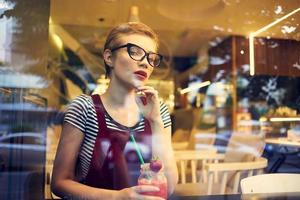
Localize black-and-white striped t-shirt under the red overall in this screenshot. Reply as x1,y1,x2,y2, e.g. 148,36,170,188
64,94,171,180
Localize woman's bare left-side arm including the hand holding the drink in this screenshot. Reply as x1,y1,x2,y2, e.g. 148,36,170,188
51,123,164,200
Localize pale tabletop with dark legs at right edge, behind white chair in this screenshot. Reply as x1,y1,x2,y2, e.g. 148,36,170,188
265,137,300,173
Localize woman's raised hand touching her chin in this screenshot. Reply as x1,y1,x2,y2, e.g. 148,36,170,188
136,86,161,121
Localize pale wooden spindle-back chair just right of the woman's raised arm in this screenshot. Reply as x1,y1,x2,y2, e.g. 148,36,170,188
175,151,267,196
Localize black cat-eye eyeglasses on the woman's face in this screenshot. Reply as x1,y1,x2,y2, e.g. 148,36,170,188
111,43,163,67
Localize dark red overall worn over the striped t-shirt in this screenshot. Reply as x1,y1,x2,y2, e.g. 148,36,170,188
84,95,151,190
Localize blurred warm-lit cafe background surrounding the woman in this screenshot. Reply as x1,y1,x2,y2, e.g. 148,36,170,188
0,0,300,199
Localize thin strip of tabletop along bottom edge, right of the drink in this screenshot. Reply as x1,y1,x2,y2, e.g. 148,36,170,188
169,192,300,200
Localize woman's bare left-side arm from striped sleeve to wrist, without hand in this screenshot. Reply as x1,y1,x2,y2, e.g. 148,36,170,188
51,123,114,199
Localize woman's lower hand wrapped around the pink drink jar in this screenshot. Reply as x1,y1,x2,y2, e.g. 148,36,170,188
116,185,164,200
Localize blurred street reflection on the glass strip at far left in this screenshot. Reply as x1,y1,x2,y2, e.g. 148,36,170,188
0,0,50,199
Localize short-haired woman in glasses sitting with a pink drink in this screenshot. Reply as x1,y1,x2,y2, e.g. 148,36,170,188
51,23,178,199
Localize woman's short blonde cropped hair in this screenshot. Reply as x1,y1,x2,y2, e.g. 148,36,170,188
103,22,159,76
